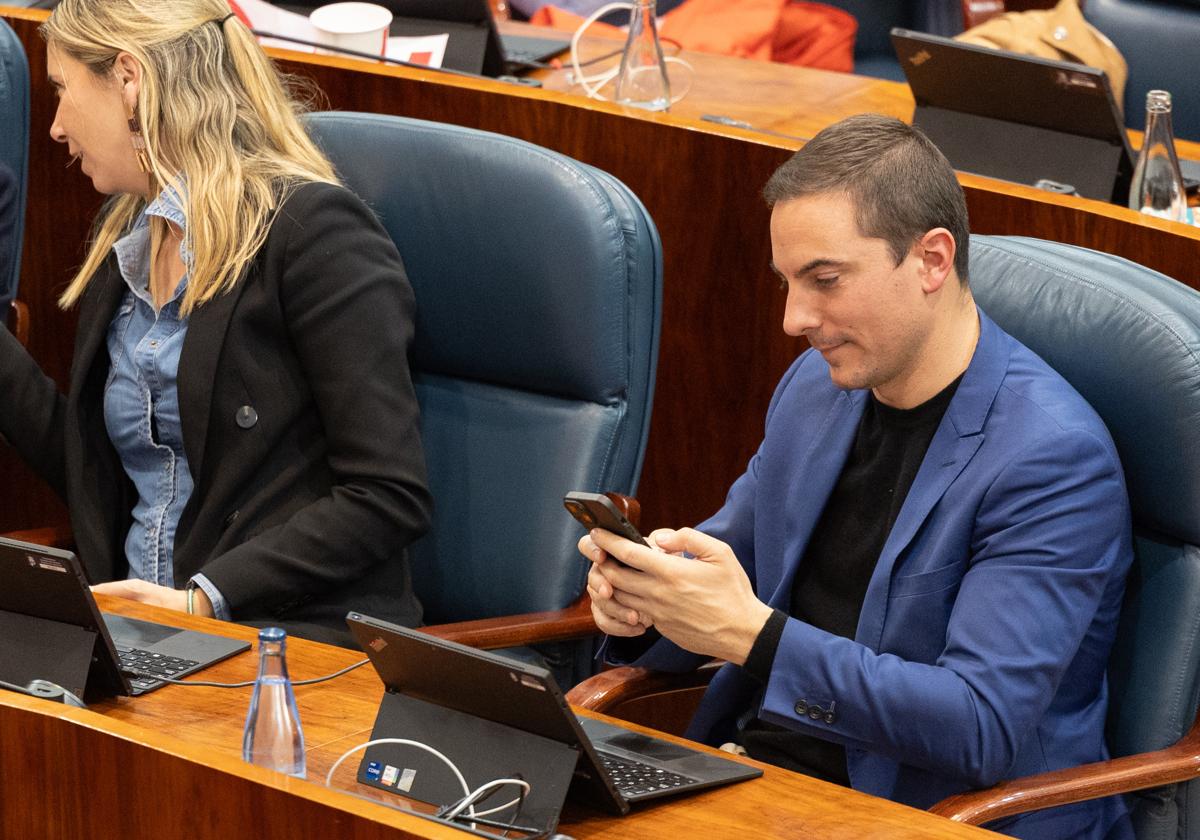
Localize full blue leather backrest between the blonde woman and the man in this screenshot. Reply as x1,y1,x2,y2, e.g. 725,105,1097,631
308,113,662,623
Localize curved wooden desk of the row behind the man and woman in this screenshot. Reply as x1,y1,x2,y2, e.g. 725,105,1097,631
0,10,1200,537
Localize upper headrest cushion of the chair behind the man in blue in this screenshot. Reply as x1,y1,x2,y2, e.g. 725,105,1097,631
971,236,1200,544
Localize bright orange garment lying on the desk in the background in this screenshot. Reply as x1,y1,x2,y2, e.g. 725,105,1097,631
529,0,858,73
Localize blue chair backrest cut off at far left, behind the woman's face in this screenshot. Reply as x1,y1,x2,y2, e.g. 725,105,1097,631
0,20,29,326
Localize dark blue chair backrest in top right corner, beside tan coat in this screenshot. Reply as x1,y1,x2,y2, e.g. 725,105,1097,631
1084,0,1200,140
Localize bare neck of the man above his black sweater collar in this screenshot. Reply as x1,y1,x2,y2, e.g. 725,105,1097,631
871,298,979,408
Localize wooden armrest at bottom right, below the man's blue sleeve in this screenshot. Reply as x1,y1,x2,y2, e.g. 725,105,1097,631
929,716,1200,826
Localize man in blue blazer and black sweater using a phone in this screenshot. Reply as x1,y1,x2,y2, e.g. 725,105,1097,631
580,115,1132,840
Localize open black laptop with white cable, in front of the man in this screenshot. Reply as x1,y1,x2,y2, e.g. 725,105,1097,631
347,612,762,830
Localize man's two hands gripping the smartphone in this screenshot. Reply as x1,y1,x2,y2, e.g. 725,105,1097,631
580,528,772,665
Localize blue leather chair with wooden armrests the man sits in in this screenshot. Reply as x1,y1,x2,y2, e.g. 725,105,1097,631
569,236,1200,840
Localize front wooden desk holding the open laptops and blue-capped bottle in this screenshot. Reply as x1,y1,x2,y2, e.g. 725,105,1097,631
0,598,996,840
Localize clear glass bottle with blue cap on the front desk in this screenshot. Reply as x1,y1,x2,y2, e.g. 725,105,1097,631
241,628,306,779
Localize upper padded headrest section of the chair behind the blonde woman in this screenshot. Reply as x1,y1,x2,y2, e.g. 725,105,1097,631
298,113,661,404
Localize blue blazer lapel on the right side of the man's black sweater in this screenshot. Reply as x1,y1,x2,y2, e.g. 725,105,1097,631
854,311,1012,650
